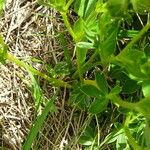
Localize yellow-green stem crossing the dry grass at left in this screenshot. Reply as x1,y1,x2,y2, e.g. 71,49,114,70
6,53,71,88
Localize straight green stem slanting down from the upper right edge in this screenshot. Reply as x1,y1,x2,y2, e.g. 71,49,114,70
116,22,150,58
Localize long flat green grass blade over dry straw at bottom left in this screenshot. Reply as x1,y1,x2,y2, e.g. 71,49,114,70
22,96,56,150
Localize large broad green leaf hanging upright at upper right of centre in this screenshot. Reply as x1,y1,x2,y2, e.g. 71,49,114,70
99,12,119,61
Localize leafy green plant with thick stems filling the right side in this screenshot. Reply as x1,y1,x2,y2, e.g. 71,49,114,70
0,0,150,150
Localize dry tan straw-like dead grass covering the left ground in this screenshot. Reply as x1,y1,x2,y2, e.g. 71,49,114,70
0,0,85,150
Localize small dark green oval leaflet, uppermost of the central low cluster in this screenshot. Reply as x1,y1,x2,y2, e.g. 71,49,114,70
95,72,108,94
